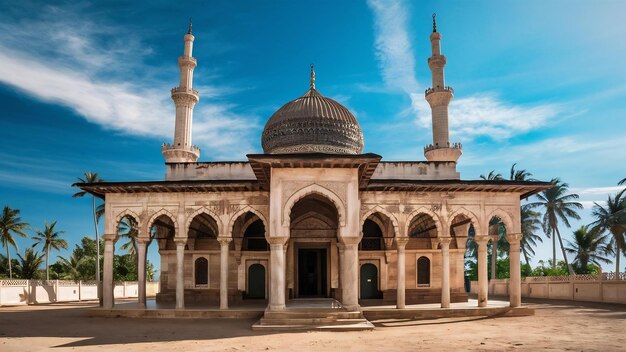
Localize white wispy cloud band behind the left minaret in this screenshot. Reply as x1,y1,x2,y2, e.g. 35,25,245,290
0,8,257,157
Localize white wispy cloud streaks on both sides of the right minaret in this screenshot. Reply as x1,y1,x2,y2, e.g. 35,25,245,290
368,0,562,141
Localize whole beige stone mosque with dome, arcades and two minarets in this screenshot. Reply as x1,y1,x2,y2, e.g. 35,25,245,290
78,15,548,324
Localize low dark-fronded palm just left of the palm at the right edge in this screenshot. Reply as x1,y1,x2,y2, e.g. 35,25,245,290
565,225,611,274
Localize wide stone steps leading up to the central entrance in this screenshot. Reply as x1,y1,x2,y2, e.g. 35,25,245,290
252,300,374,331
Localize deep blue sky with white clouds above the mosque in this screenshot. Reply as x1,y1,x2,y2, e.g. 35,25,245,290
0,0,626,269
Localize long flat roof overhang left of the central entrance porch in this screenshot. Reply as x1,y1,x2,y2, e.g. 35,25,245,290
72,180,260,199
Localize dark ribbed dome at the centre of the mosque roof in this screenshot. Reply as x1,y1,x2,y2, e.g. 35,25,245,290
261,88,363,154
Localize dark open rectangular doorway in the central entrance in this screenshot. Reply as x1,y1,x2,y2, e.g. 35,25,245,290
298,248,328,297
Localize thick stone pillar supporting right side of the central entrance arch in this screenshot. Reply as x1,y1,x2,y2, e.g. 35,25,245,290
341,237,360,311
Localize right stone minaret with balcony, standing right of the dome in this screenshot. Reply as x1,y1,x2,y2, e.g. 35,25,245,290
424,14,462,162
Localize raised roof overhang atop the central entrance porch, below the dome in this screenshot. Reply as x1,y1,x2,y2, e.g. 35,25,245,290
247,153,382,190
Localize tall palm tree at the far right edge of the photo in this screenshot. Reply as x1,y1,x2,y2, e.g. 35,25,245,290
591,189,626,279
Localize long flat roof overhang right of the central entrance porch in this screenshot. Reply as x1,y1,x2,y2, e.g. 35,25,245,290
364,179,554,199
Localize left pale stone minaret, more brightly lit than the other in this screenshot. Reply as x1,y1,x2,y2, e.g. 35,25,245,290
162,19,200,163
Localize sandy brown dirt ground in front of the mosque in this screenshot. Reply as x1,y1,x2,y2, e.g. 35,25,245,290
0,301,626,352
